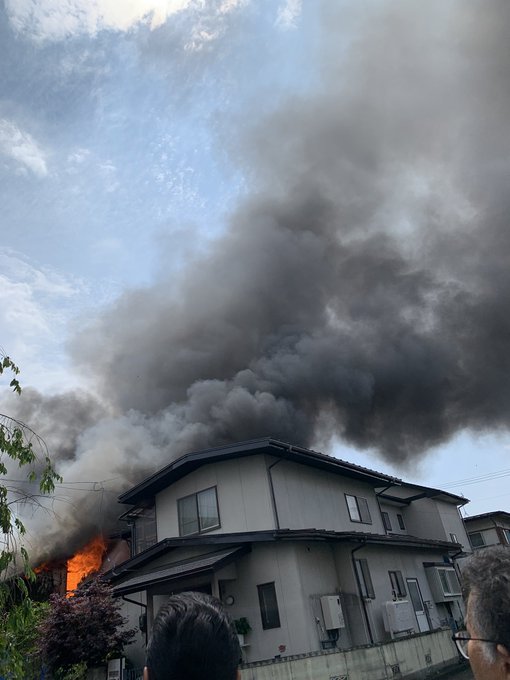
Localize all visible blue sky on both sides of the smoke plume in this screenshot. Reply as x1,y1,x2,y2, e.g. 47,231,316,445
0,0,510,548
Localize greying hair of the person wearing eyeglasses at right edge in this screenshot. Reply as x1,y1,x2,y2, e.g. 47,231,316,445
462,546,510,650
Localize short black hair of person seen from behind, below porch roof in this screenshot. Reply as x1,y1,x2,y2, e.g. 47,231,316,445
146,592,241,680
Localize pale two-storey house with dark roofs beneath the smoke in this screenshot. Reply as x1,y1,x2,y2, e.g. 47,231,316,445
109,438,469,661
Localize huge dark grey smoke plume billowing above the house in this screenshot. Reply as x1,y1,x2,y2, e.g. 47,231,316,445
3,0,510,560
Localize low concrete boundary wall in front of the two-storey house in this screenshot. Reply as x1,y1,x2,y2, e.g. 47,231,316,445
241,629,459,680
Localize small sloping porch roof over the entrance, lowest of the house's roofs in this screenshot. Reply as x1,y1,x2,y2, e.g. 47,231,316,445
113,546,249,595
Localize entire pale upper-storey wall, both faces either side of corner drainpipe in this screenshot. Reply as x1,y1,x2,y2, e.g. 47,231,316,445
156,456,386,541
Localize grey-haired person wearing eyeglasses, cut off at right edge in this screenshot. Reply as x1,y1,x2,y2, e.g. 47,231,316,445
453,546,510,680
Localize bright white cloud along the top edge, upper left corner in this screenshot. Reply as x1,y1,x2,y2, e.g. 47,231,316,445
6,0,246,41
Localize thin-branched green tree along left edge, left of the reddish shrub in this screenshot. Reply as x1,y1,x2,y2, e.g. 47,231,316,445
0,351,62,680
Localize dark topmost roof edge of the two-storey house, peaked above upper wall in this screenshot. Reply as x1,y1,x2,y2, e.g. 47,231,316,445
119,437,402,505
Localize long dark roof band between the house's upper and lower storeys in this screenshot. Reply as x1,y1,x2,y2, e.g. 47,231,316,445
104,529,462,592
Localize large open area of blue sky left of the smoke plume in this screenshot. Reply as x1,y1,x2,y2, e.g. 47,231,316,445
0,0,313,390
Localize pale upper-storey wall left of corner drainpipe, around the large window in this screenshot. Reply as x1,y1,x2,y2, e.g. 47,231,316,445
156,456,275,541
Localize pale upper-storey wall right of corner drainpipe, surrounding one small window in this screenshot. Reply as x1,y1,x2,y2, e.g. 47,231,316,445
271,460,384,534
